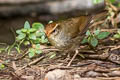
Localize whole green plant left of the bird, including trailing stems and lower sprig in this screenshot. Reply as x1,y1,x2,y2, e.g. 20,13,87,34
8,21,48,58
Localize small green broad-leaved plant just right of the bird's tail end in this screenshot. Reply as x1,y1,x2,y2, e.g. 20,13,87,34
81,29,110,47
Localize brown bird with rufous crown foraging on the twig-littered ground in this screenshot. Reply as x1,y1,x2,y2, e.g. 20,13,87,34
45,11,106,50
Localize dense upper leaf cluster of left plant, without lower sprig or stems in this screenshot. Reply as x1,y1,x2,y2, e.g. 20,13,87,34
16,21,48,45
